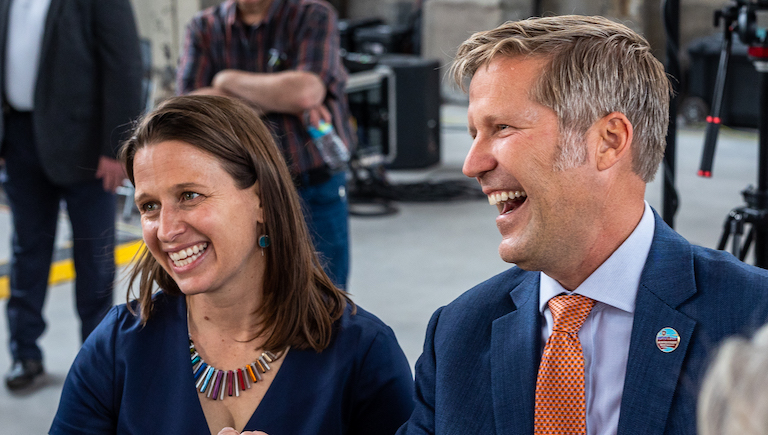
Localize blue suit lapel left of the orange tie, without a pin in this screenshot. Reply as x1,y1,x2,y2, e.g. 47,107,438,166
491,273,541,434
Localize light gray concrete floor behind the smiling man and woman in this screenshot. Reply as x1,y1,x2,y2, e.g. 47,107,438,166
0,105,758,435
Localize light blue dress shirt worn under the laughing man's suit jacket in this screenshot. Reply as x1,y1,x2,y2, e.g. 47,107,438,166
539,202,655,435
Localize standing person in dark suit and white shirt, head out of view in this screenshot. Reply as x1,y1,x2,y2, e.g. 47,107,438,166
0,0,143,390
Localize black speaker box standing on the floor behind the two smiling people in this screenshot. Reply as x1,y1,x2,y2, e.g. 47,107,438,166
379,54,440,169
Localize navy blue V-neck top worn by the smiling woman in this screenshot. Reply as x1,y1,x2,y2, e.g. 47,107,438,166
50,292,413,435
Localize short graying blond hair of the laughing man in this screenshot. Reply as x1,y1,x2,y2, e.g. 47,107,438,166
451,15,672,182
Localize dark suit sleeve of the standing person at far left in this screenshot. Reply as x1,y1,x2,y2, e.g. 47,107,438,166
93,0,144,158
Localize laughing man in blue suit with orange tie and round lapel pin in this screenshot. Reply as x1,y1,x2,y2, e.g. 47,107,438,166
398,16,768,435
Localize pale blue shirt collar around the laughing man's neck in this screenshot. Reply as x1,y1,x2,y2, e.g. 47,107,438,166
539,202,656,313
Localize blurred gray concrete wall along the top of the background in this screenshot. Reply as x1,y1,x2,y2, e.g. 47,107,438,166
132,0,726,101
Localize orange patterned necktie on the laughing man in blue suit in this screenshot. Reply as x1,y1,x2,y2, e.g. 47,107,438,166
534,294,595,435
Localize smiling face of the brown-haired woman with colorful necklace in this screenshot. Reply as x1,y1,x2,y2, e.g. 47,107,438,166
133,141,264,295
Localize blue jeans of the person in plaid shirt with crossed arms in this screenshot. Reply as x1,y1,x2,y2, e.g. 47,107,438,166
299,172,349,289
